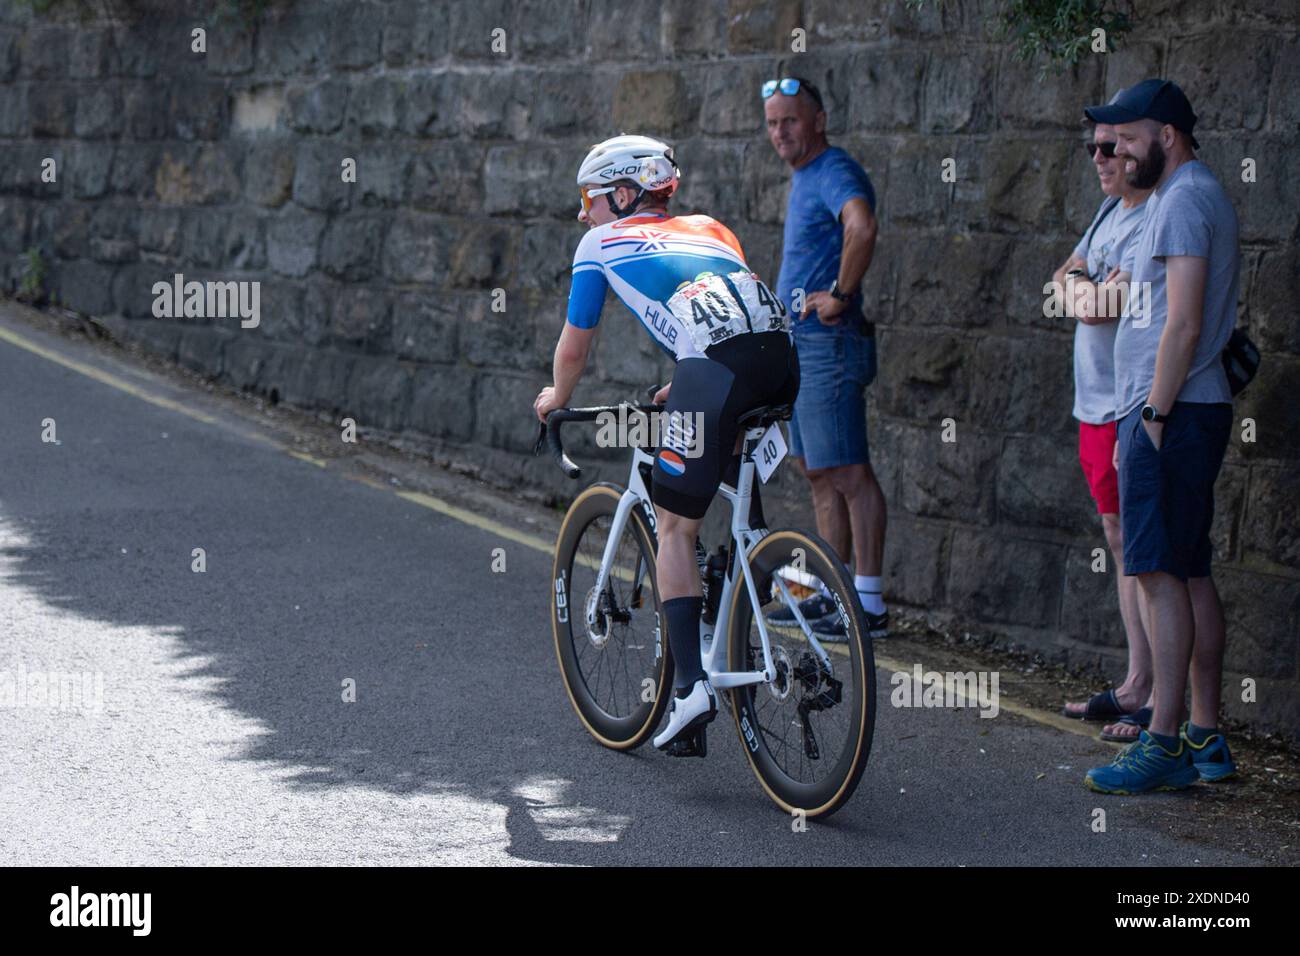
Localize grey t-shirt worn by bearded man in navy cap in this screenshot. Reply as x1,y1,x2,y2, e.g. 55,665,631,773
1115,160,1240,418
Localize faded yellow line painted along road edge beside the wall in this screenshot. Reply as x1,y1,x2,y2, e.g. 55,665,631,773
0,325,1105,743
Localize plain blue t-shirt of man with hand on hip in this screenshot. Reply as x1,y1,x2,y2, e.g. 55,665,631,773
776,146,876,336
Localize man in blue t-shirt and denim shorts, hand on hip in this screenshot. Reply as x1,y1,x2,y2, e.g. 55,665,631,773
762,77,889,640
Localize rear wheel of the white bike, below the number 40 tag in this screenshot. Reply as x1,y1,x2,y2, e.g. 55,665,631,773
727,531,876,817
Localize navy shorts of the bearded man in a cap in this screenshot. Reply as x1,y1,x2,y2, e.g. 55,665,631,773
1118,402,1232,581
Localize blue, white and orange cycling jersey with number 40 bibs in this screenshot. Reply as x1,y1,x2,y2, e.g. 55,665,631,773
568,212,785,360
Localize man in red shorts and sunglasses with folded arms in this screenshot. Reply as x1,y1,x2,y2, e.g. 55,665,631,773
1053,91,1152,740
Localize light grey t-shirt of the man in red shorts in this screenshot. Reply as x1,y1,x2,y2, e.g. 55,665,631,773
1074,199,1147,425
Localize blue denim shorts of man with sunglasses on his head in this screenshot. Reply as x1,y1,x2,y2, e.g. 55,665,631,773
790,320,876,468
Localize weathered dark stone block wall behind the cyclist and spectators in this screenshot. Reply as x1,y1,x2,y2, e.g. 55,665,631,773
0,0,1300,732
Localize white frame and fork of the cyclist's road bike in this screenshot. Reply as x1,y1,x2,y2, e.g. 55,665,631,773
586,428,832,689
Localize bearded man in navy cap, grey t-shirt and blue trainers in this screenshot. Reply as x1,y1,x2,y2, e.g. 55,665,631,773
1084,79,1240,793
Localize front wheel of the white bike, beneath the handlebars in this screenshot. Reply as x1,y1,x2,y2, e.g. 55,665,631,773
551,483,672,750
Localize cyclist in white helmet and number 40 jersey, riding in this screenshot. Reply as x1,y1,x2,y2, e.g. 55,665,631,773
533,135,798,753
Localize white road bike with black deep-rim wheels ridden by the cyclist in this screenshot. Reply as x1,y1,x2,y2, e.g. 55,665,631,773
534,403,876,818
